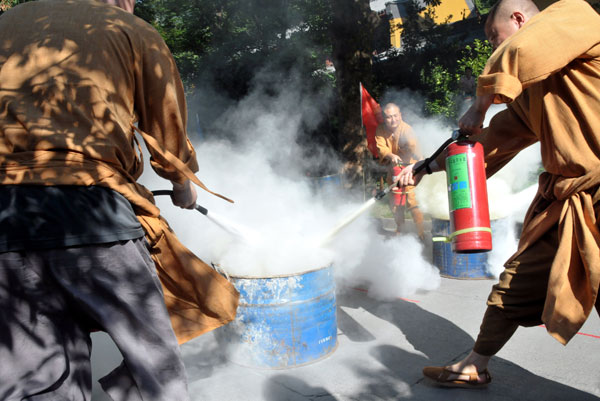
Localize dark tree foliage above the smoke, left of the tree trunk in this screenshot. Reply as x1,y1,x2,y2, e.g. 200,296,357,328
136,0,331,98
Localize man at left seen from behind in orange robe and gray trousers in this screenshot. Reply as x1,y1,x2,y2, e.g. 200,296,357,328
0,0,238,401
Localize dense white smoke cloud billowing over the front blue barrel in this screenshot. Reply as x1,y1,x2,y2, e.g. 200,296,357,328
142,72,440,299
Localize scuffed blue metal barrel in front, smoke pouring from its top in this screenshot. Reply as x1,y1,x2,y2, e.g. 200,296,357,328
215,266,337,369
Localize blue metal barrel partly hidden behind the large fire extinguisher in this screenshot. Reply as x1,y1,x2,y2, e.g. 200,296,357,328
431,218,494,279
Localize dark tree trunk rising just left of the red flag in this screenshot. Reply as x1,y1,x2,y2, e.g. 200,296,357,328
331,0,379,187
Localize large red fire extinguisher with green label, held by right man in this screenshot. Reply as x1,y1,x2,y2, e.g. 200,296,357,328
446,140,492,253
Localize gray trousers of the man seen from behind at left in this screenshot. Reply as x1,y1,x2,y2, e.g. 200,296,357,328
0,238,189,401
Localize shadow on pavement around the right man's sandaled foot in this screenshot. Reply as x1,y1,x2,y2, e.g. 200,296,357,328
337,290,598,401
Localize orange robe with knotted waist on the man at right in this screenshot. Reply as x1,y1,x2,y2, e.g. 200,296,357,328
468,0,600,344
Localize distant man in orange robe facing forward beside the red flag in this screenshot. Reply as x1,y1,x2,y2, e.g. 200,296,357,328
375,103,424,239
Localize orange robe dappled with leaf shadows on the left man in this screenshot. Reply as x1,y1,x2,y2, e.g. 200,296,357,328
0,0,239,343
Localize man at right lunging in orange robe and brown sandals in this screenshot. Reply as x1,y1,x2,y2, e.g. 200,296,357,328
399,0,600,387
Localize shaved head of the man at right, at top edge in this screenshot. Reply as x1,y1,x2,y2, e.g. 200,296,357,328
485,0,540,49
